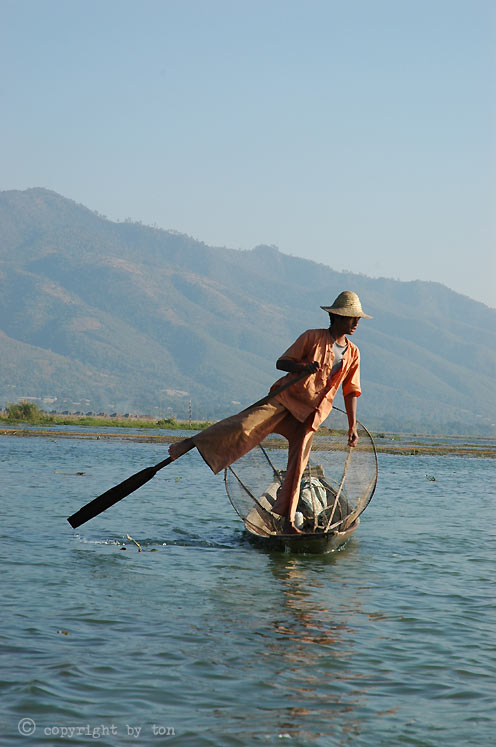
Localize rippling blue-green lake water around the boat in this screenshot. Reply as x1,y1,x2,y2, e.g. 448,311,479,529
0,436,496,747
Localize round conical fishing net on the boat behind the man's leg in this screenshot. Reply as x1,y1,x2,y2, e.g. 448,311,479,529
224,407,377,536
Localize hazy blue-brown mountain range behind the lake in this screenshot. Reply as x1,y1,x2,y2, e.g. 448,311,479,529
0,188,496,435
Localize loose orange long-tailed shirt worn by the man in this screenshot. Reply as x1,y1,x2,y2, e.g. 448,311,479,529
271,329,361,431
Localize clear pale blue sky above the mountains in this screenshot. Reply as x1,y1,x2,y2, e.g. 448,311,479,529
0,0,496,306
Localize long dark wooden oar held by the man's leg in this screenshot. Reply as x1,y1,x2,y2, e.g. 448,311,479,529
67,371,312,529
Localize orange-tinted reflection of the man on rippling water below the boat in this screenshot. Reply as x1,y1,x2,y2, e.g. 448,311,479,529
267,548,362,739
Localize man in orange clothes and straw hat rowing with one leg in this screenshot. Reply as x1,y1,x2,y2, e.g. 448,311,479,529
169,291,372,532
